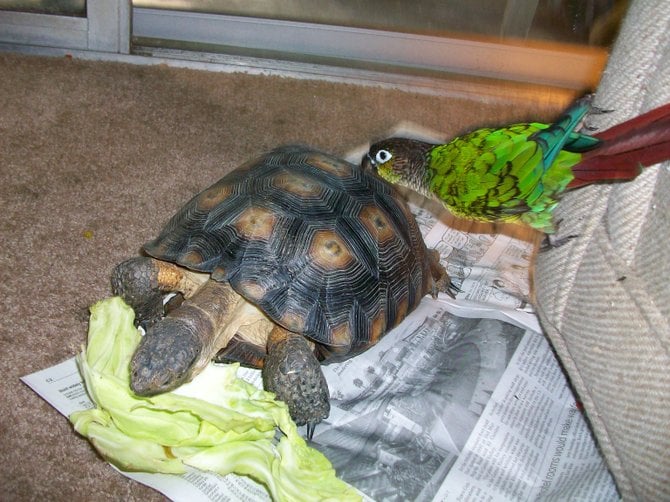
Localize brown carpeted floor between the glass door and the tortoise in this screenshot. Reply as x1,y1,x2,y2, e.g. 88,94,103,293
0,53,558,501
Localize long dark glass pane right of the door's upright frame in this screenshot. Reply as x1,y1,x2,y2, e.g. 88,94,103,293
133,0,628,45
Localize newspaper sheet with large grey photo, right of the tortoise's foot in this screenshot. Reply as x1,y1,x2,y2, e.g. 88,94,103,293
315,298,618,501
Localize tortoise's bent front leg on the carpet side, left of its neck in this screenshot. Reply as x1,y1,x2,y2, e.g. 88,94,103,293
112,256,207,330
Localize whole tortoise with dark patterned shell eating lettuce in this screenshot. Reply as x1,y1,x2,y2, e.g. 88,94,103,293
112,146,450,438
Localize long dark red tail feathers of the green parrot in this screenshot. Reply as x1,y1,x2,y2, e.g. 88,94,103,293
568,103,670,188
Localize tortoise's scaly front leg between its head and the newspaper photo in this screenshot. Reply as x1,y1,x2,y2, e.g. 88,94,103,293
262,326,330,439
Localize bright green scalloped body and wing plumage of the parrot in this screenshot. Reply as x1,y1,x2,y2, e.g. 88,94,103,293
426,105,598,232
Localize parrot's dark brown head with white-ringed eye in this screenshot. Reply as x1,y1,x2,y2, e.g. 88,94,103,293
362,138,434,193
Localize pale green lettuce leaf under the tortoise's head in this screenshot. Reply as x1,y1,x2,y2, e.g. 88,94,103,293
69,297,361,501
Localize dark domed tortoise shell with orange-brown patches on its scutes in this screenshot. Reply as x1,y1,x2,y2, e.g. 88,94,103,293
144,147,433,361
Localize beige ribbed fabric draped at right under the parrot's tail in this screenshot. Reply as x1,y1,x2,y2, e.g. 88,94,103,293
535,0,670,500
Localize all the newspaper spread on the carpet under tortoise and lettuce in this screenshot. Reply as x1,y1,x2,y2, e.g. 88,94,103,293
22,131,619,502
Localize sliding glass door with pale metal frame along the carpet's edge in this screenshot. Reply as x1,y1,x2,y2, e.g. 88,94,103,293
0,0,627,90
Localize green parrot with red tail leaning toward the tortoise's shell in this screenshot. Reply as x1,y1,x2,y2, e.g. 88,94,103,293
363,96,670,234
